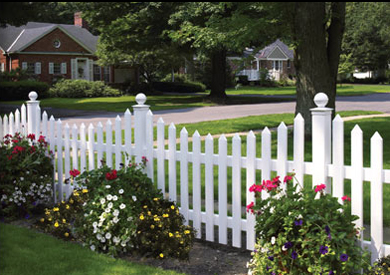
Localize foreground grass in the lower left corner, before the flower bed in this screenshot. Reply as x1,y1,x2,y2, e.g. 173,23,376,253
0,223,185,275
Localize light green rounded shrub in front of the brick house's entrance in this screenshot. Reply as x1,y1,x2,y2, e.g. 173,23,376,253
49,79,120,98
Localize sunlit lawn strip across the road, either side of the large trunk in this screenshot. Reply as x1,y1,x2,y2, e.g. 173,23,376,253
226,84,390,96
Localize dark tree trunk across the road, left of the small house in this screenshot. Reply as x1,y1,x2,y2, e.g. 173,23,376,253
209,49,227,103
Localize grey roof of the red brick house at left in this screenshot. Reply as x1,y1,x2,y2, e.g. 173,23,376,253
0,22,98,53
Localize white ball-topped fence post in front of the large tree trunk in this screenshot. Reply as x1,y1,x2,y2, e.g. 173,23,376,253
310,93,333,194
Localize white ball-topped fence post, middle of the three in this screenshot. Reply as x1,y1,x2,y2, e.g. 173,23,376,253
133,93,150,163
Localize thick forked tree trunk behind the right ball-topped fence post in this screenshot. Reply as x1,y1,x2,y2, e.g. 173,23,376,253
293,2,345,135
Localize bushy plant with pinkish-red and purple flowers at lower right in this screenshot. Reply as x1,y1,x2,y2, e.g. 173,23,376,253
247,175,370,274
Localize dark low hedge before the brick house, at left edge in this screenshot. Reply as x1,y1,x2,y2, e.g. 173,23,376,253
0,80,49,101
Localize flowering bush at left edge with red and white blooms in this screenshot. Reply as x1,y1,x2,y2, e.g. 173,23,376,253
0,133,53,219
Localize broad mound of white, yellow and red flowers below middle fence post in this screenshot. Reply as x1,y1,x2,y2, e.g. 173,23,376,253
39,161,195,259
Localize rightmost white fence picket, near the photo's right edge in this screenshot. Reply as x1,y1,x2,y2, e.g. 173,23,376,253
370,132,383,262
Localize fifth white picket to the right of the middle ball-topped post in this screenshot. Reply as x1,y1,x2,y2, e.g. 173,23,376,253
192,131,202,239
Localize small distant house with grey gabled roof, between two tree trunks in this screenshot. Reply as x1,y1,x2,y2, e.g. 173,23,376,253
229,39,295,81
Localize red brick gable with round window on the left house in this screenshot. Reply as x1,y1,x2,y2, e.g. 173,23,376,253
21,27,91,54
